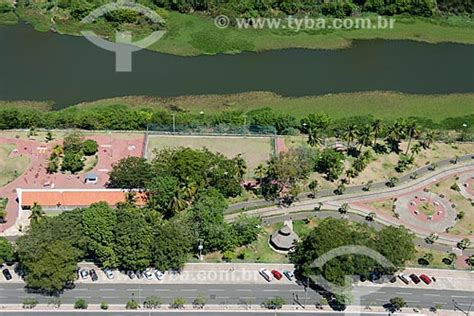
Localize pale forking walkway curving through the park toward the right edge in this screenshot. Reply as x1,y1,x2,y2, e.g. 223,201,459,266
226,155,474,246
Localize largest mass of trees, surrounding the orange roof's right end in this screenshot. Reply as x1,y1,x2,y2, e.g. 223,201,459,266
17,148,261,291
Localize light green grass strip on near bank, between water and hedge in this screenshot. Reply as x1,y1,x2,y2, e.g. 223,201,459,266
78,91,474,122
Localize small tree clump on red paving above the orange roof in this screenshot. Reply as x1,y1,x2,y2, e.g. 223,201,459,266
47,132,99,173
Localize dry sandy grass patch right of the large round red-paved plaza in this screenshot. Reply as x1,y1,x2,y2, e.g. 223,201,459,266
430,178,474,235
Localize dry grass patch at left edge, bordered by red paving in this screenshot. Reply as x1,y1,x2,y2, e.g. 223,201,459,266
0,144,30,187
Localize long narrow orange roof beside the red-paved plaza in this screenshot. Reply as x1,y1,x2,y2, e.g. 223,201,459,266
17,189,146,206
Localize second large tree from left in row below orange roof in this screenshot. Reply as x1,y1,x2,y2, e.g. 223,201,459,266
82,202,119,268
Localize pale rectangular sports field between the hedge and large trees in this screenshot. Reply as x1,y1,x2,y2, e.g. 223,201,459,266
148,135,272,177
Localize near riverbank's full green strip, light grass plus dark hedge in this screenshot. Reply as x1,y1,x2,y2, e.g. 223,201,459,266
0,92,474,136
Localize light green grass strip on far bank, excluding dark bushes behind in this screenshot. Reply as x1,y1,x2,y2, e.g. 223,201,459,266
9,9,474,56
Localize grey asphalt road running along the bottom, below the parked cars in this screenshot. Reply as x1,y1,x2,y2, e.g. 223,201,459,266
0,283,474,308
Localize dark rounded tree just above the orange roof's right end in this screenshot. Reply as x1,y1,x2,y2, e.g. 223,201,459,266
108,157,153,189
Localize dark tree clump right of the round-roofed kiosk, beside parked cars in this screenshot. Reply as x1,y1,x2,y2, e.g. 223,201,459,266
290,218,415,285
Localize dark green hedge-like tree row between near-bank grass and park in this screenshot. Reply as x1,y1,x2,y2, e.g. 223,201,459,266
0,105,474,138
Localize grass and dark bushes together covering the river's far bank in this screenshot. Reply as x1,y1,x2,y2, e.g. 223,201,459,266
0,0,474,55
